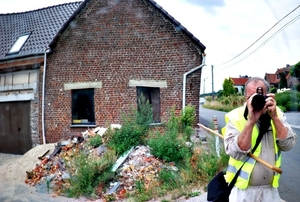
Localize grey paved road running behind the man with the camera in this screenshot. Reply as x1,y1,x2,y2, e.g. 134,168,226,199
200,107,300,202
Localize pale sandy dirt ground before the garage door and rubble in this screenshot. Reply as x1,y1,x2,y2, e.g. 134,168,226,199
0,129,206,202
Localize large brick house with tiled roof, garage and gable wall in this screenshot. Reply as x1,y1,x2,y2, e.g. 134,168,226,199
0,0,205,153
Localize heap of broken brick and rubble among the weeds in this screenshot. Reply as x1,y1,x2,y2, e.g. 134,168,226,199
25,126,169,198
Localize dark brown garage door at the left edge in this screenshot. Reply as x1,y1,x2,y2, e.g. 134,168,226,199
0,101,32,154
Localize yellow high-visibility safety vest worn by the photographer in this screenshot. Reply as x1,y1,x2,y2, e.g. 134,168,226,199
222,106,282,189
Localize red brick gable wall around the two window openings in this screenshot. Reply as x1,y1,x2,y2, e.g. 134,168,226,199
45,0,202,142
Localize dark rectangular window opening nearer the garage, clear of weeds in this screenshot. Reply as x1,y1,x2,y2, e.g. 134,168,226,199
72,89,95,125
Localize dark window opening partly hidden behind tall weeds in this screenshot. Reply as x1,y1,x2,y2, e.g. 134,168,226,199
137,87,160,123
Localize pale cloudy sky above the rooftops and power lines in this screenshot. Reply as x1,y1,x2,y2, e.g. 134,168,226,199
0,0,300,93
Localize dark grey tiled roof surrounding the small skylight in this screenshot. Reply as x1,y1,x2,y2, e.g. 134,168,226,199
0,1,82,60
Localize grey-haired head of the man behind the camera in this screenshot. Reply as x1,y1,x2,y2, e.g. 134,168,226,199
245,77,270,99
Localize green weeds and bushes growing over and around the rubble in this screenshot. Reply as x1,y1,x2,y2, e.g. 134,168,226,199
62,98,228,201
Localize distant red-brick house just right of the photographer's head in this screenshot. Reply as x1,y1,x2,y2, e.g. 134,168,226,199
265,64,299,89
